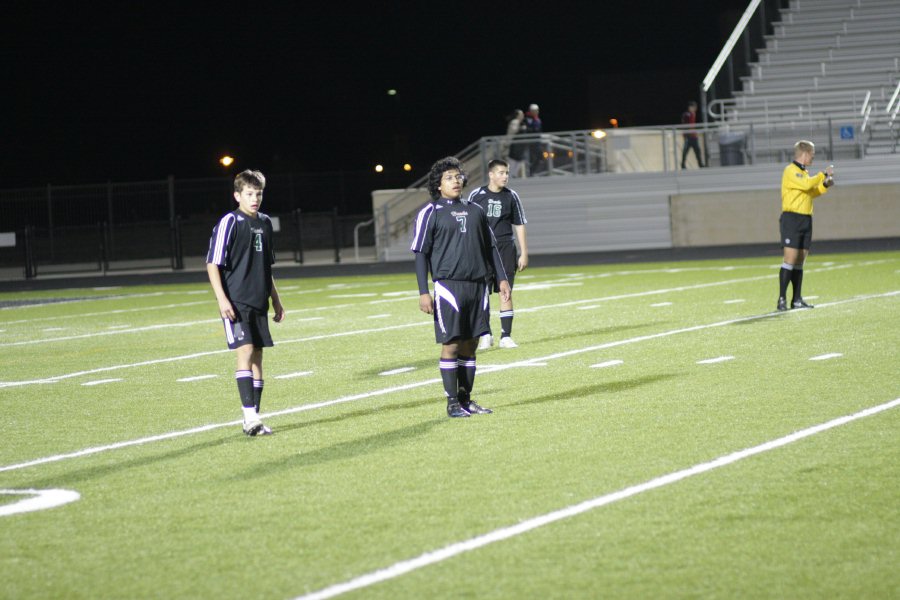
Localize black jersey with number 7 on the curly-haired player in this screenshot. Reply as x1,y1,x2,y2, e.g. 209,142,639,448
411,198,505,281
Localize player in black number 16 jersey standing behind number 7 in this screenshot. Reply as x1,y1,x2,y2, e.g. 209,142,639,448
469,160,528,350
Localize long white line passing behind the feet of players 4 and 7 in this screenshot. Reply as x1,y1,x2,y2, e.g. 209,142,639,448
0,290,900,473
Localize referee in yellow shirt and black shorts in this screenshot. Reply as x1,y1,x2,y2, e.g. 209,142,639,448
777,140,834,310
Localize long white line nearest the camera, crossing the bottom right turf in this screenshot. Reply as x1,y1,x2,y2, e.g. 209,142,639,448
296,398,900,600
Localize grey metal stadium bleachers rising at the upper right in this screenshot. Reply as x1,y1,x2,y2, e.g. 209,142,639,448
710,0,900,160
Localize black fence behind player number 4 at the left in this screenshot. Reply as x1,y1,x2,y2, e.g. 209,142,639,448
0,173,383,278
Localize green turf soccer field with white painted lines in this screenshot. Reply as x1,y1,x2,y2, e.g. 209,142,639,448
0,252,900,599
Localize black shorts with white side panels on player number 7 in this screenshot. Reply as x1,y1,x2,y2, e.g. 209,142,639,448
434,279,491,344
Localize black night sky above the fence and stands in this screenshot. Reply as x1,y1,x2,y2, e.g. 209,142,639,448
0,0,748,188
